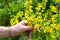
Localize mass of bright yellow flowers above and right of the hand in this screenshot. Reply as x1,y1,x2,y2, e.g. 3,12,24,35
10,0,60,38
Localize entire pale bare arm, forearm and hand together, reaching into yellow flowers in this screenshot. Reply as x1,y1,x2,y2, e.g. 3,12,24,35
0,21,31,38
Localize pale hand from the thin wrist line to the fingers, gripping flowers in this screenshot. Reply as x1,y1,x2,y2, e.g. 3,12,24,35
12,21,31,36
